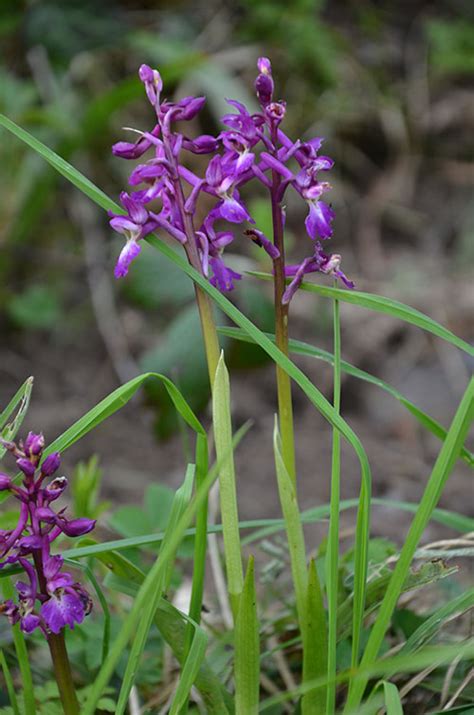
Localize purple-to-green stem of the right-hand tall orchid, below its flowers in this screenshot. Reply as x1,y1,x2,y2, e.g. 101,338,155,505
270,171,296,483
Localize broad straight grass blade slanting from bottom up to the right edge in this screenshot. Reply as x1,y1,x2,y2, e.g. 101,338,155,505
347,378,474,707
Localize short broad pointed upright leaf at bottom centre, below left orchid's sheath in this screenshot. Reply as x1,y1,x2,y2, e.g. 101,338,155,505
234,556,260,715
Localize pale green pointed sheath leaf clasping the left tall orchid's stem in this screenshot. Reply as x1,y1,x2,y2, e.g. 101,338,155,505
212,353,244,621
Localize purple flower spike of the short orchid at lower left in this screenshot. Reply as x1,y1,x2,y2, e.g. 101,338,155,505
0,432,95,636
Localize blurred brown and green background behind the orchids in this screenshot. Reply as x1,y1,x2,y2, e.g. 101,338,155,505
0,0,474,535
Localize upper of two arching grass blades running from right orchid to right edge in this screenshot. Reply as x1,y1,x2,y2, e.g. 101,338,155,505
248,271,474,355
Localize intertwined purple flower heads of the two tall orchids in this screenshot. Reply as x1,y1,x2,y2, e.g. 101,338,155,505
110,58,353,302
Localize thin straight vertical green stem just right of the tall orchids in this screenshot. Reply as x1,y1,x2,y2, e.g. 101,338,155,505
326,292,341,715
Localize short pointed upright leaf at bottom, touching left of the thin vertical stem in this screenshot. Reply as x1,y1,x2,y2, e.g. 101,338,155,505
301,559,328,715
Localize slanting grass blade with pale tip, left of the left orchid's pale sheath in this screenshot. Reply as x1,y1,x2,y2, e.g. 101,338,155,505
115,464,195,715
